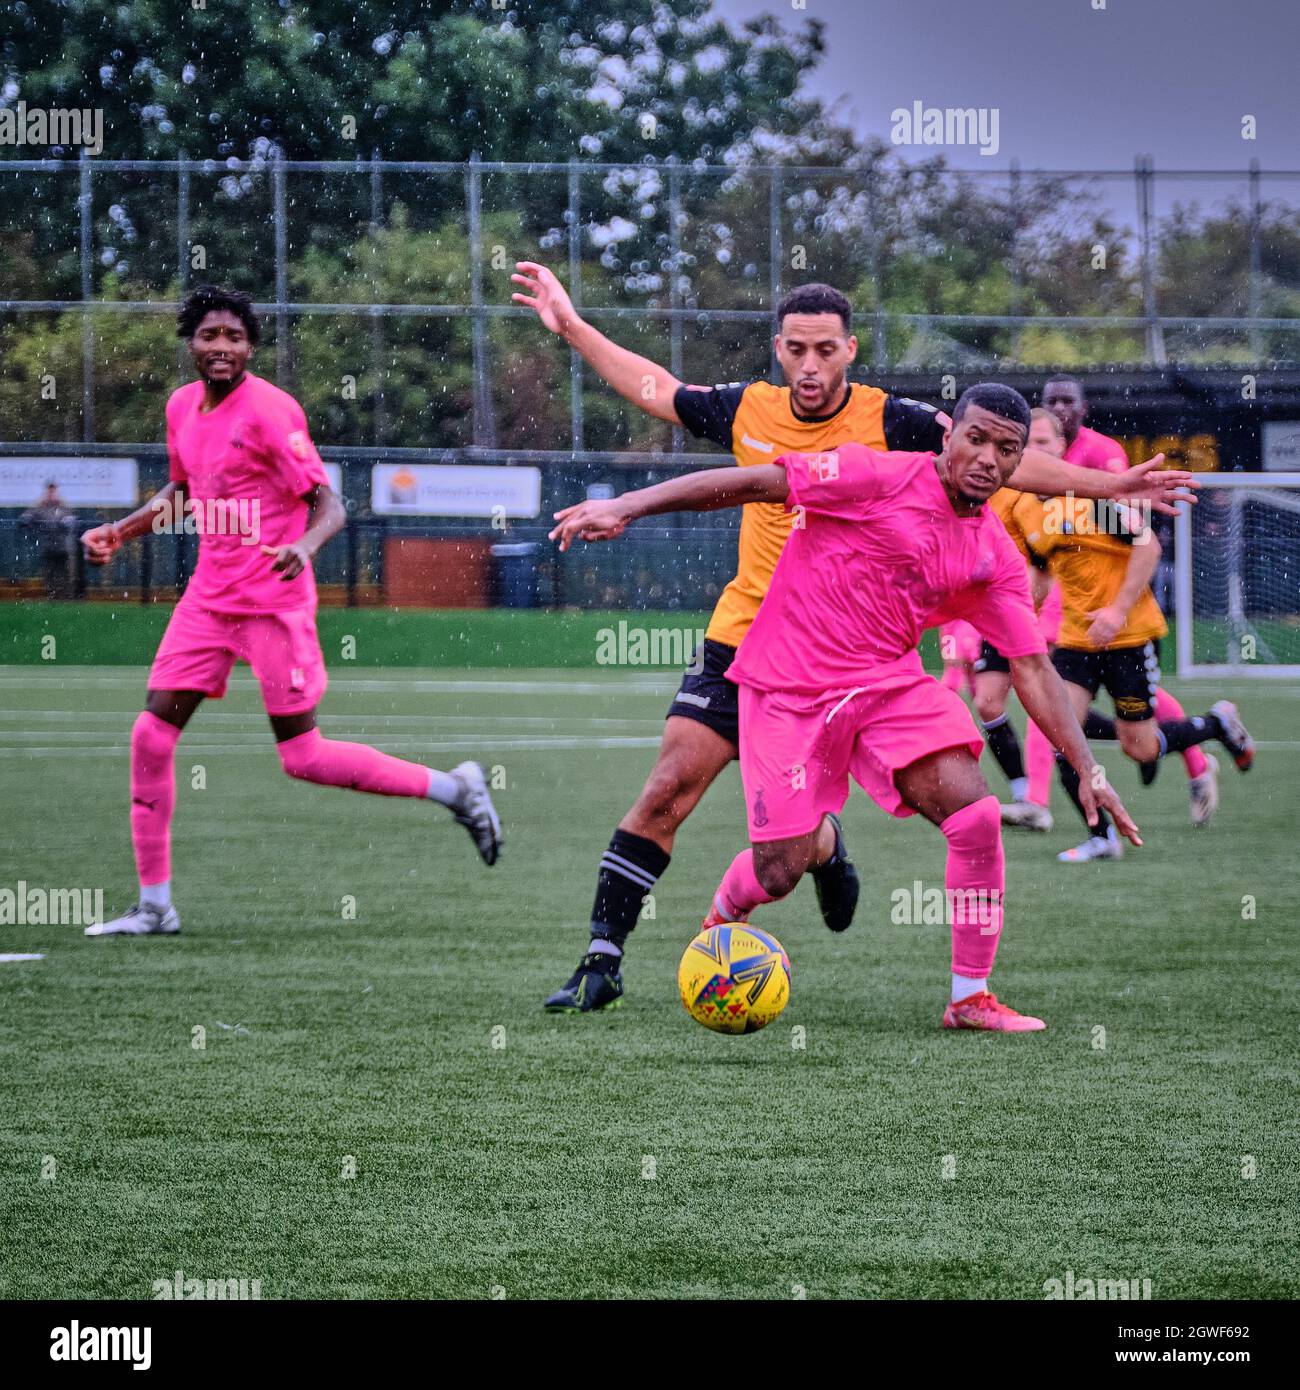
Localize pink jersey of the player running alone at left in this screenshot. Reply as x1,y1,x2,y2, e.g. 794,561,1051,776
167,373,330,613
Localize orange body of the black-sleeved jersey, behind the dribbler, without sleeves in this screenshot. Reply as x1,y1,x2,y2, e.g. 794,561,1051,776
705,381,886,646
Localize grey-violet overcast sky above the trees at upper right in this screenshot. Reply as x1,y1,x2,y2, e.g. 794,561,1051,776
715,0,1300,175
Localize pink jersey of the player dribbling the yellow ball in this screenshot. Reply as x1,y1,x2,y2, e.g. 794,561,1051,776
727,443,1046,694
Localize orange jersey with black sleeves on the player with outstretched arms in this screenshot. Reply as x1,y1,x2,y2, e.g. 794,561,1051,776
673,381,943,646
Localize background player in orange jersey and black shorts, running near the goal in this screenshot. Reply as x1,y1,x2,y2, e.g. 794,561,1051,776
1002,493,1254,863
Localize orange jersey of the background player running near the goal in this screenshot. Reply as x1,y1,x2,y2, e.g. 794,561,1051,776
993,488,1169,651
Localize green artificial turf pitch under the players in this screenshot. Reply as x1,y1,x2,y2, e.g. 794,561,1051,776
0,664,1300,1298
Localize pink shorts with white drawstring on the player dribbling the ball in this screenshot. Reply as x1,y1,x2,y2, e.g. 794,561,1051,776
740,653,984,844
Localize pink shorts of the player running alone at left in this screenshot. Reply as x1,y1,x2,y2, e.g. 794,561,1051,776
149,599,327,714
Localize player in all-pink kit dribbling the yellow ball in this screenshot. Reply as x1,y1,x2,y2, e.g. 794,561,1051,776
552,384,1141,1033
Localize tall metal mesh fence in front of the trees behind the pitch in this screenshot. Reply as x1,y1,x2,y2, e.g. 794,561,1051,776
0,153,1300,607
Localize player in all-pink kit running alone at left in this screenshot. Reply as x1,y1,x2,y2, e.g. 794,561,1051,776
82,285,502,935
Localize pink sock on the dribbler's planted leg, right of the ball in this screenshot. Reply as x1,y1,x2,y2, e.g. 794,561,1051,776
939,795,1007,980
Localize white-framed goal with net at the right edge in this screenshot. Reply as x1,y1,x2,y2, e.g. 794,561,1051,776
1173,473,1300,678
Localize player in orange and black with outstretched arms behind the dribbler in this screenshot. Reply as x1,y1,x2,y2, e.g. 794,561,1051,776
512,261,1190,1013
